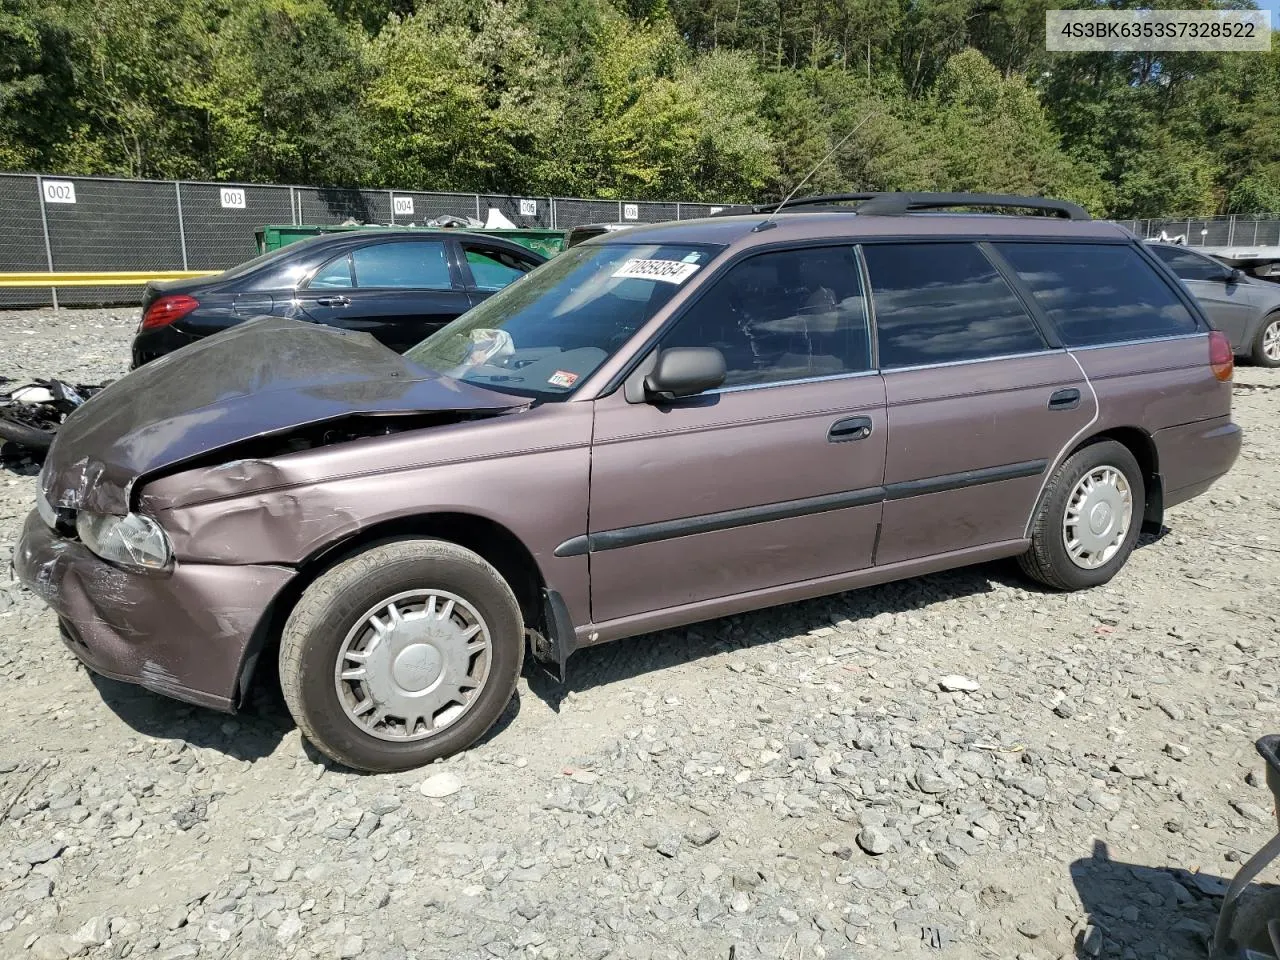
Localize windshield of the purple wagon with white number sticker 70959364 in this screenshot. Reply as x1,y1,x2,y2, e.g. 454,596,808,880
406,243,717,399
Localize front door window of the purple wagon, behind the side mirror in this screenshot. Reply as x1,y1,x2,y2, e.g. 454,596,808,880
662,246,870,387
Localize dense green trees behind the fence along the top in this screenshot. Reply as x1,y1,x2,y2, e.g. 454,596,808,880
0,0,1280,216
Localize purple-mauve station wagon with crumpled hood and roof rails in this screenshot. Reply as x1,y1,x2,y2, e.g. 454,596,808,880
15,195,1240,771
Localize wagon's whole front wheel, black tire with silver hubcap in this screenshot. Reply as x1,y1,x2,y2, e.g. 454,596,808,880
280,540,525,772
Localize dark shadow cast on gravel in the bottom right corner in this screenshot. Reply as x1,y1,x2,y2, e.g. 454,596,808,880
1070,840,1271,960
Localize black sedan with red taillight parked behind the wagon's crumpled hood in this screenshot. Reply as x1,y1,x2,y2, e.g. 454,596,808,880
133,229,547,367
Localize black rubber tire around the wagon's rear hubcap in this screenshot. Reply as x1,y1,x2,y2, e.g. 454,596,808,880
1018,440,1147,590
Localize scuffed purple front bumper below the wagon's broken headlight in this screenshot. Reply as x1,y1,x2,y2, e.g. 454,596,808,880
14,512,293,710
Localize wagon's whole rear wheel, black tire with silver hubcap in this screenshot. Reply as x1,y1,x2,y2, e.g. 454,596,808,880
1018,440,1147,590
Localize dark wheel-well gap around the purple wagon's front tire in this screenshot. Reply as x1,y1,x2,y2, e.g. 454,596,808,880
234,512,547,705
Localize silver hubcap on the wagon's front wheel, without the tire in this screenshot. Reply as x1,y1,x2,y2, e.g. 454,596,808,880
334,590,493,741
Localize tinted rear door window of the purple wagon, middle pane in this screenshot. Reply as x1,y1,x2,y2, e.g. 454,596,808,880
863,243,1046,370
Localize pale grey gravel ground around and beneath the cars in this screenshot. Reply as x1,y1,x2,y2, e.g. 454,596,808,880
0,311,1280,960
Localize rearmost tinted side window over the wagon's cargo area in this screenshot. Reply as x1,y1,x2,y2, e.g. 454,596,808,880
996,243,1197,347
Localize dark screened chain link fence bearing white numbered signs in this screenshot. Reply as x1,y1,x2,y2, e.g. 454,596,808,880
0,174,746,308
